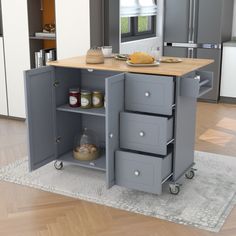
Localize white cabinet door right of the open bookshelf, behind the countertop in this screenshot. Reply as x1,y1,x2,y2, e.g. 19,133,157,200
55,0,90,59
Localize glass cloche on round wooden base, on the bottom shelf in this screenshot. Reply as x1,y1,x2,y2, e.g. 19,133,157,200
73,128,100,161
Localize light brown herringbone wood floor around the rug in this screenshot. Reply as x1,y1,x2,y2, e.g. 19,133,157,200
0,103,236,236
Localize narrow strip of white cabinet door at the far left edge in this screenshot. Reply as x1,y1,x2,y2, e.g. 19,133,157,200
0,38,8,116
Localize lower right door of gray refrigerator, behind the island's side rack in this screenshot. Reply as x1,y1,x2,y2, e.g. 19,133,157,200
197,49,221,101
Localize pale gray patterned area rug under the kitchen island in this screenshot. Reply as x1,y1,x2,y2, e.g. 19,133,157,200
0,152,236,232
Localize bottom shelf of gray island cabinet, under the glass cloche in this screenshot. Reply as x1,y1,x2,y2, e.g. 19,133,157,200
58,150,106,171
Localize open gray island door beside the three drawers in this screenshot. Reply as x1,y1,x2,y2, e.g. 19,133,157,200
106,74,125,188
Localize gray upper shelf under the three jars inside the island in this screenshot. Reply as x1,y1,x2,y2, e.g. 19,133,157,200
57,104,106,117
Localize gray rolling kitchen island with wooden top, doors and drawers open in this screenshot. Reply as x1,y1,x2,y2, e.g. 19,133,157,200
25,57,213,194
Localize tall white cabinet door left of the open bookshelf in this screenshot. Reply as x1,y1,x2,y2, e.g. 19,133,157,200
2,0,30,118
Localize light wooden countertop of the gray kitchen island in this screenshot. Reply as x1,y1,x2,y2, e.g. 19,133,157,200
47,56,214,77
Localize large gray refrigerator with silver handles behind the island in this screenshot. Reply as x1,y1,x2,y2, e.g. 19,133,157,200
163,0,234,102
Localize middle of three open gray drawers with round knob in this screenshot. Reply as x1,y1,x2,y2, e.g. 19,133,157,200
120,112,173,155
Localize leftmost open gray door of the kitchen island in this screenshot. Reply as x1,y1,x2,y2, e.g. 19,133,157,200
25,67,56,171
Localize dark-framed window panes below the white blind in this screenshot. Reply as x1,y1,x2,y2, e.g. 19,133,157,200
121,16,156,42
